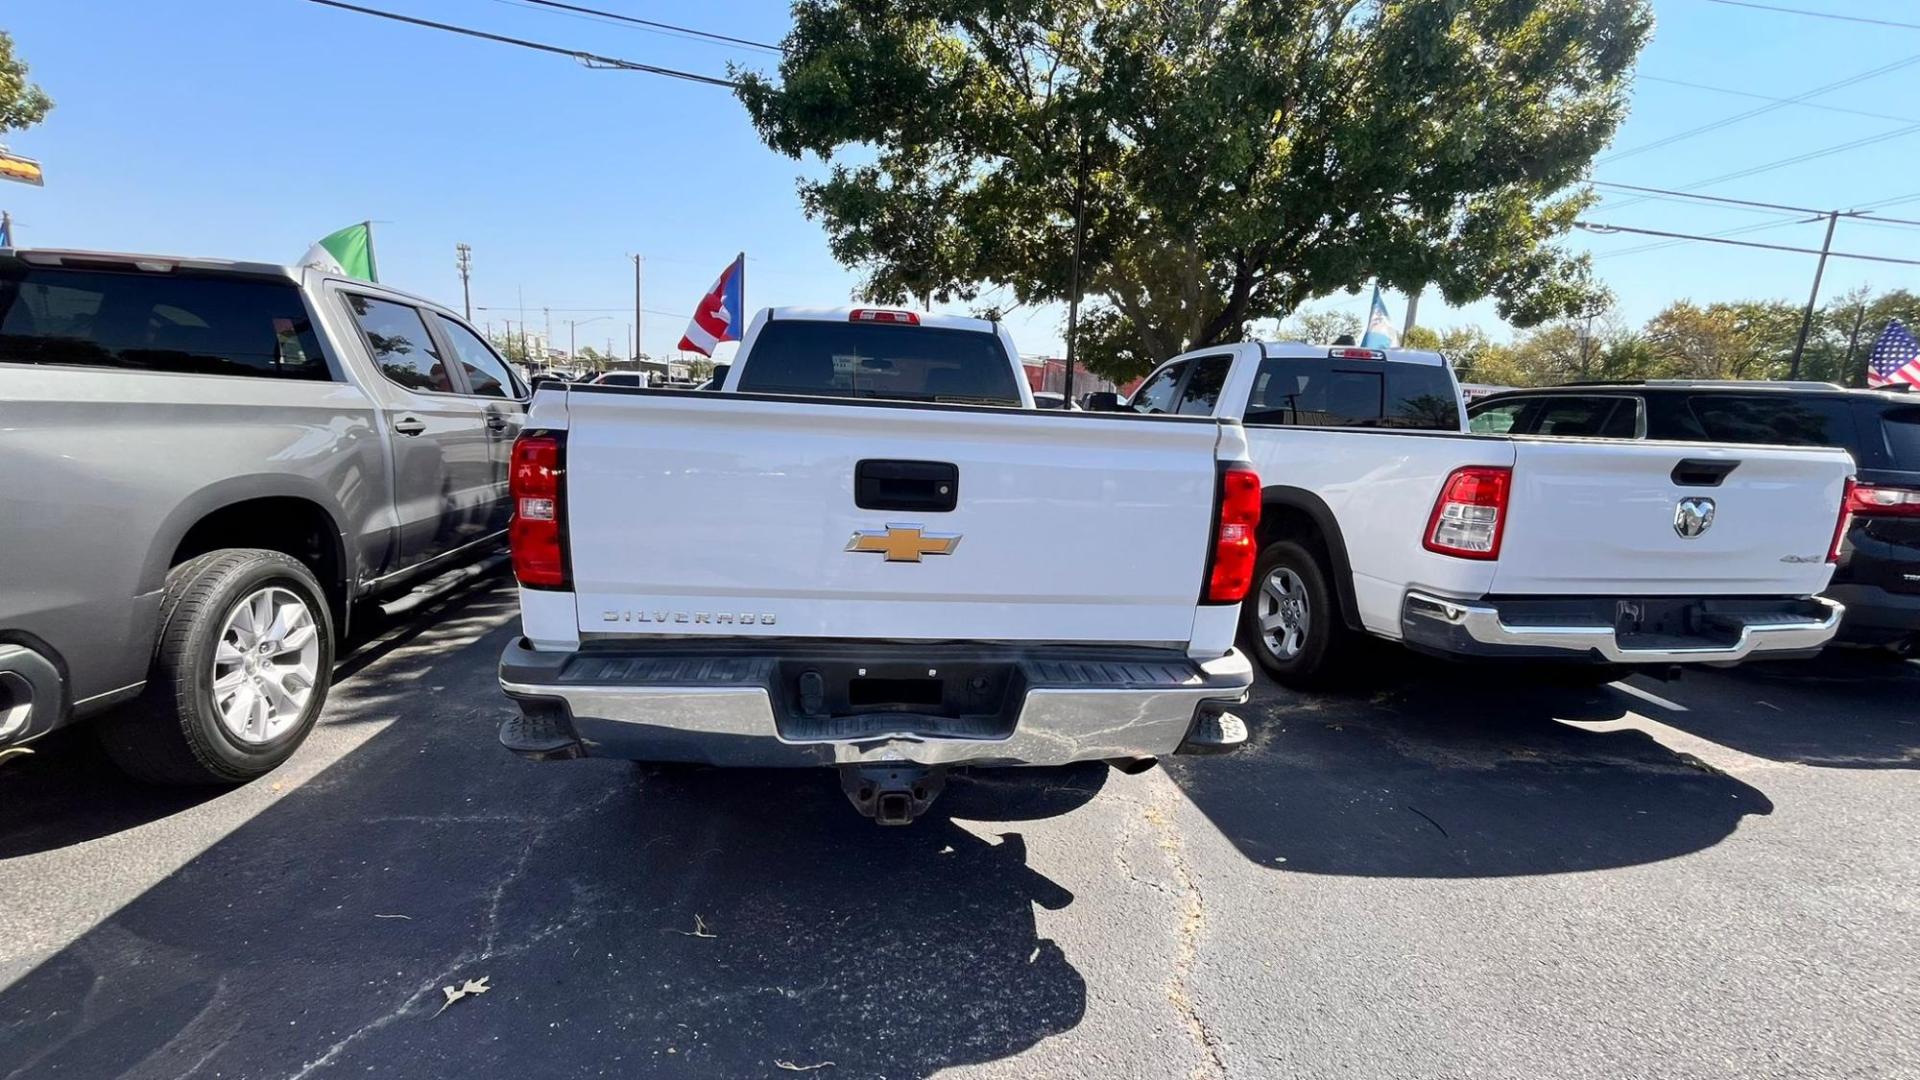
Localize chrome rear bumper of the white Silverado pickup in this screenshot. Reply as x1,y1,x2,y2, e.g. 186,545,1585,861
499,640,1254,767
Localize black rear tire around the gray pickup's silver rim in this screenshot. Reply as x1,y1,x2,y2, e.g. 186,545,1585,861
96,548,334,784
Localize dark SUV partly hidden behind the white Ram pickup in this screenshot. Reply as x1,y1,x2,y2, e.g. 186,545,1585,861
1467,380,1920,651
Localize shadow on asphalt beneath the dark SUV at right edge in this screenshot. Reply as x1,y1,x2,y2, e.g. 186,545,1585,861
1640,650,1920,769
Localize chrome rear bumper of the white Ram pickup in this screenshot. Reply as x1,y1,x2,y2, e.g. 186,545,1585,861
1402,592,1845,665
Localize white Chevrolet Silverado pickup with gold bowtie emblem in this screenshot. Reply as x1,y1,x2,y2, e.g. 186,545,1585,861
499,307,1260,824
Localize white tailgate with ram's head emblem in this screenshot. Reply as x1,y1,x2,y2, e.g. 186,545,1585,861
1492,438,1853,596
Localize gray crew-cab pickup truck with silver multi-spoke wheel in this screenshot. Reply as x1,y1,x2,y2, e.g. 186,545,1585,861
0,248,528,784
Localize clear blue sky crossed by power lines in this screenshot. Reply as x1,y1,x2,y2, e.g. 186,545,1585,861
0,0,1920,352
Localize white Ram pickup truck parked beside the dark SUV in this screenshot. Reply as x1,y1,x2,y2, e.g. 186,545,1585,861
1117,342,1853,686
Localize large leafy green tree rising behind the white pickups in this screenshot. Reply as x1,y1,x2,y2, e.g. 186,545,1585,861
735,0,1651,377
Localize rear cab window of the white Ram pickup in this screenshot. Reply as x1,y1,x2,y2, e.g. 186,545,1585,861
1246,357,1459,430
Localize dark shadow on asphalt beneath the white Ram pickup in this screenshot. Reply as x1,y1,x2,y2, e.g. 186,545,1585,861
1169,653,1772,878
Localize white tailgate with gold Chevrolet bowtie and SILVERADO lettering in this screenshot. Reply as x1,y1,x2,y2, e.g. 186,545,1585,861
566,388,1219,646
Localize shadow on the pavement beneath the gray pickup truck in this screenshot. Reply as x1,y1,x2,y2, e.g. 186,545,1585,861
0,577,505,859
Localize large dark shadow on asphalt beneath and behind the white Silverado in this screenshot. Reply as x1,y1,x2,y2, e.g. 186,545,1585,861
0,611,1106,1078
